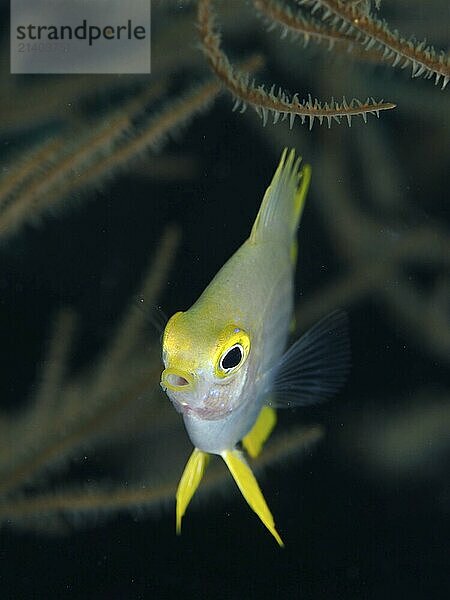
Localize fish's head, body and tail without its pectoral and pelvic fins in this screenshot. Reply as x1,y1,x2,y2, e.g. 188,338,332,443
161,152,307,454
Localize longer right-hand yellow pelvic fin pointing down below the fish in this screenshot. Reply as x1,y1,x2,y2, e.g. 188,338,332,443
222,450,284,548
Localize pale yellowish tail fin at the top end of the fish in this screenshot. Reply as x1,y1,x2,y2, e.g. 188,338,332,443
250,148,311,243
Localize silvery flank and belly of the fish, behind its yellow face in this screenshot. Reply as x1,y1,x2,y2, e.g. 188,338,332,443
183,241,293,454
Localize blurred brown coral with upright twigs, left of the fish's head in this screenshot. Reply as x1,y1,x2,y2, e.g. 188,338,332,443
0,229,183,496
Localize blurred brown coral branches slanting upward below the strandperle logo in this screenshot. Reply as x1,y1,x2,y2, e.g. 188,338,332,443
0,55,262,238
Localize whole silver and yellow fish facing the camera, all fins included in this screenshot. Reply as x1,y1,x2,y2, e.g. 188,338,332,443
160,148,350,546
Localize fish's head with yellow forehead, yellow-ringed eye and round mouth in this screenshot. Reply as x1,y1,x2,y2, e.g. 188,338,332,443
161,309,251,420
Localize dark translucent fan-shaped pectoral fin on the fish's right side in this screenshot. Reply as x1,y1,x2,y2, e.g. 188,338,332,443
270,311,350,407
